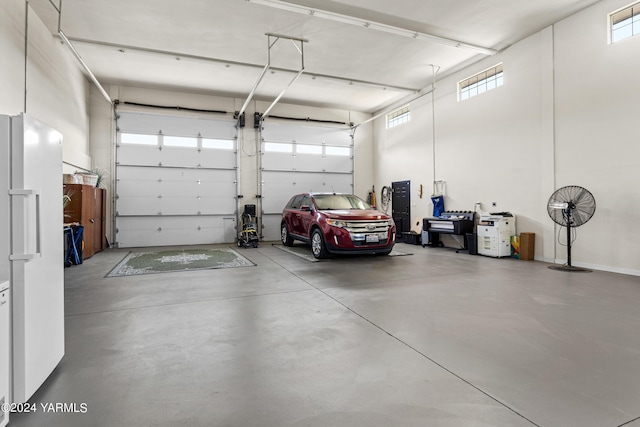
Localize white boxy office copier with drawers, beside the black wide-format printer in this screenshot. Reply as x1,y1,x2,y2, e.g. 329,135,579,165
477,212,516,258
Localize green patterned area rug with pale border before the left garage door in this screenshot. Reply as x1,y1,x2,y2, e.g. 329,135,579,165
105,248,255,277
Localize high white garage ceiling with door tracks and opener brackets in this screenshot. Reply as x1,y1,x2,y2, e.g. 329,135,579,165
29,0,598,112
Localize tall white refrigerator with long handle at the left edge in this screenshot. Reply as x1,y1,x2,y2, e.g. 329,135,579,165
0,114,64,418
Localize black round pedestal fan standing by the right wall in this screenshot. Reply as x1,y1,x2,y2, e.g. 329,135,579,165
547,185,596,272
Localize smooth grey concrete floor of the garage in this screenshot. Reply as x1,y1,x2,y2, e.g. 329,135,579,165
10,243,640,427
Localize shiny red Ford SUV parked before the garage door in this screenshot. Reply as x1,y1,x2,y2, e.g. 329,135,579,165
280,193,396,258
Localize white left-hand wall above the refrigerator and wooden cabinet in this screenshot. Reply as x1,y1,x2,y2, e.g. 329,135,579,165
0,0,91,172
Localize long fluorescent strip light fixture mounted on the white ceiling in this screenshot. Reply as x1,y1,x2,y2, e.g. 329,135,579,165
246,0,498,56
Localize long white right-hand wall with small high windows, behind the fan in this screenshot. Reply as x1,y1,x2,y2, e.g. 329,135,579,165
374,0,640,274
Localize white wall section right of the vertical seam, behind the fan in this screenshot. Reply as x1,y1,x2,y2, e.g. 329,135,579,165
555,0,640,273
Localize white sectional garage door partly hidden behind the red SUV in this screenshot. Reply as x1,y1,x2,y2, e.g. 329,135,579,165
261,121,353,240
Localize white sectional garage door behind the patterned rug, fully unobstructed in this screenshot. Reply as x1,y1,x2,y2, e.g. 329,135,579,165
115,112,237,247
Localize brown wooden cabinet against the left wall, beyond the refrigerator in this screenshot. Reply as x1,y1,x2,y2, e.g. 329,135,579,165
64,184,106,259
